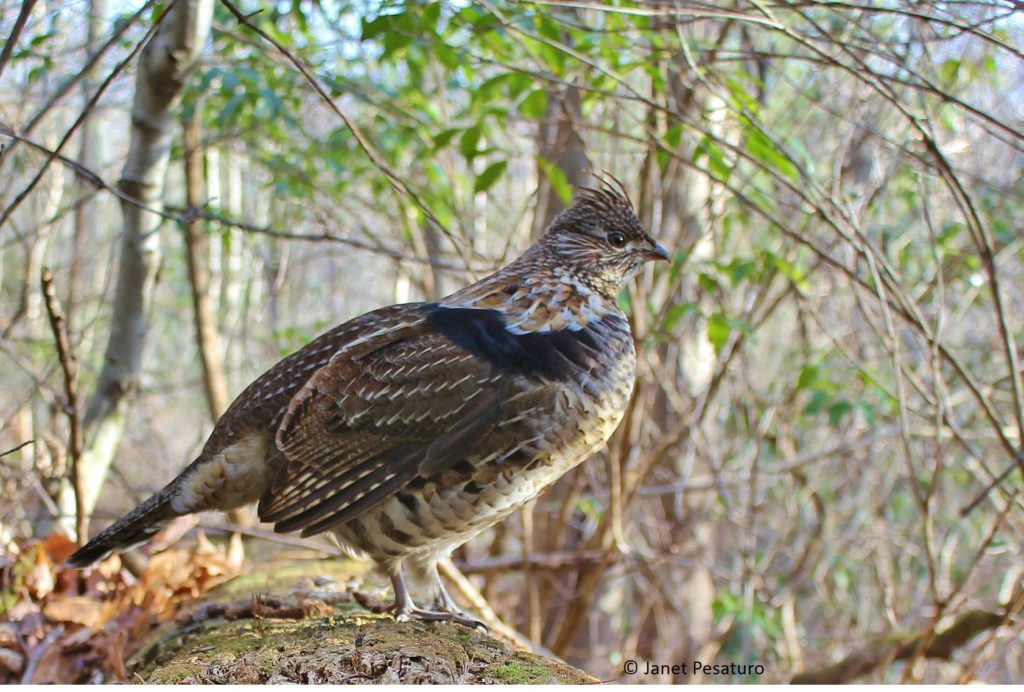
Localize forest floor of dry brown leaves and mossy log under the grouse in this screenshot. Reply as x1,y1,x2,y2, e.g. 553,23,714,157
0,535,596,684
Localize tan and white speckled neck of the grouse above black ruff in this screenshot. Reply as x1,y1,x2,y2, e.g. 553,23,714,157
438,246,625,334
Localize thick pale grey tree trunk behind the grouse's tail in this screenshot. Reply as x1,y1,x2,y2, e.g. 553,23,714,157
74,0,213,524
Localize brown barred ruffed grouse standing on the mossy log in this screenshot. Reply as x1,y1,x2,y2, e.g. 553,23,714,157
69,186,669,624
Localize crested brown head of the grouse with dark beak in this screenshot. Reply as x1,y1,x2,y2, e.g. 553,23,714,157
541,184,670,297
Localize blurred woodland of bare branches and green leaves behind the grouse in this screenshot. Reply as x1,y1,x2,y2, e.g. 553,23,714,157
0,0,1024,683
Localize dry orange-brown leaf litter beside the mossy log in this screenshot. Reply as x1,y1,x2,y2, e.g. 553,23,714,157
0,533,239,684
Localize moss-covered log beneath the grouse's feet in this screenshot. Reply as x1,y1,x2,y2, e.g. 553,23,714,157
128,560,596,684
